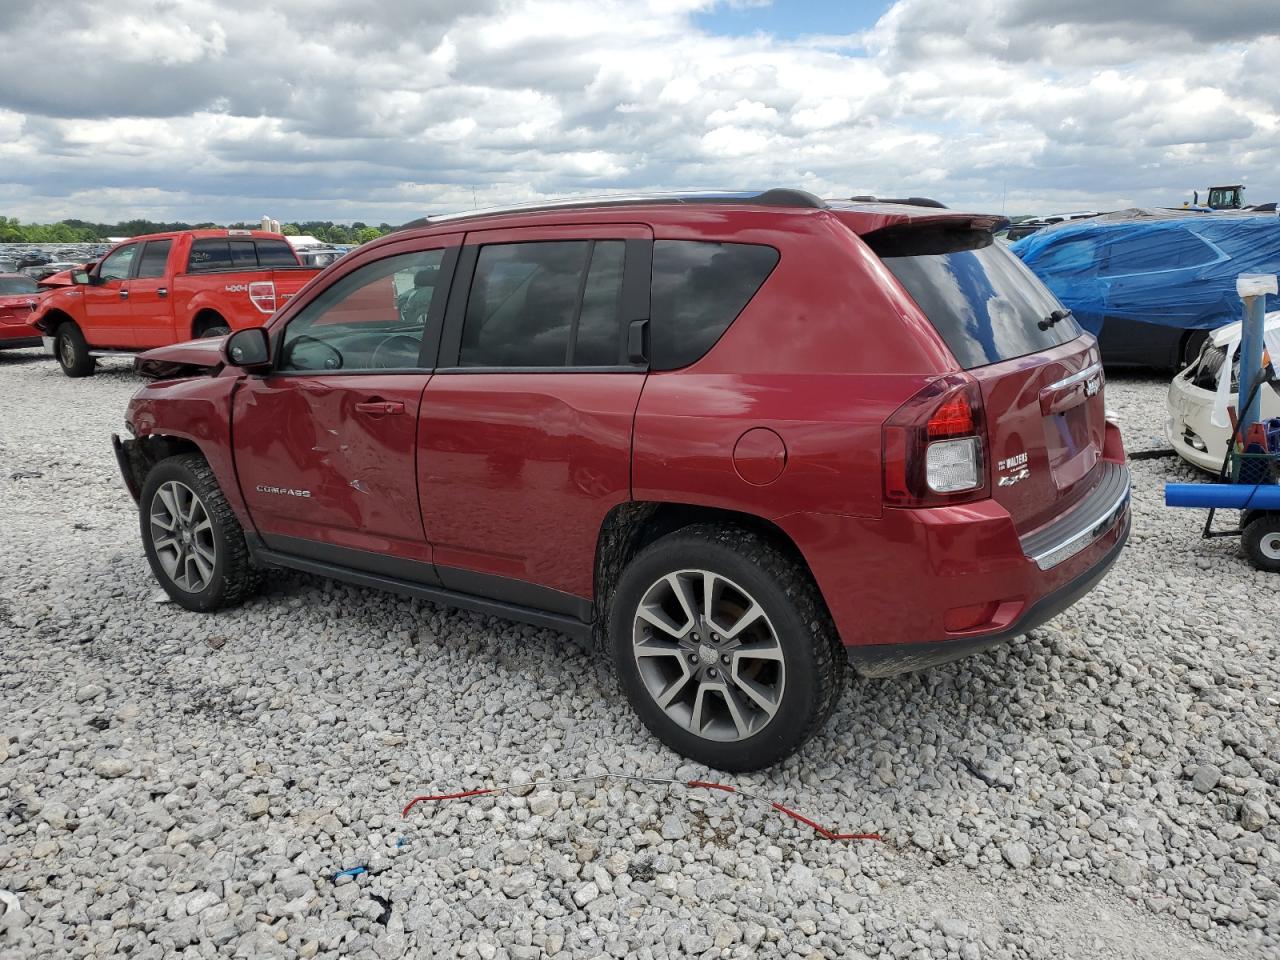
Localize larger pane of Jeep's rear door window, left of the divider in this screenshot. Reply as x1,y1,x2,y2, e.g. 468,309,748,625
458,241,590,366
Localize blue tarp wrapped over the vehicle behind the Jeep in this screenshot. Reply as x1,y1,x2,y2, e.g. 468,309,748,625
1010,211,1280,334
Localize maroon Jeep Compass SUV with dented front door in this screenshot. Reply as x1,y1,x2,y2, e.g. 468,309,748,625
115,189,1129,771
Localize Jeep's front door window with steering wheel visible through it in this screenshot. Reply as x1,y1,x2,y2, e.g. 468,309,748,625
276,250,444,371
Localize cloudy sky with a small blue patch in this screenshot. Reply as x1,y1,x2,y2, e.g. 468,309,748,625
0,0,1280,223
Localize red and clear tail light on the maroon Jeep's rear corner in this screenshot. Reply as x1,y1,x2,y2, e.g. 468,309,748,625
883,374,989,507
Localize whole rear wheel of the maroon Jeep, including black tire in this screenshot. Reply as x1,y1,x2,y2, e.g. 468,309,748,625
608,526,847,771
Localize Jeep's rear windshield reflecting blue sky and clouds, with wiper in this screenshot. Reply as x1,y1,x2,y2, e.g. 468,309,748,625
863,228,1080,370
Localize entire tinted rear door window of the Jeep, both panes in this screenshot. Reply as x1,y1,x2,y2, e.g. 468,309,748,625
458,239,626,367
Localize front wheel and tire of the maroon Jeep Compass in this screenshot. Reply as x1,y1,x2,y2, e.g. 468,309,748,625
140,453,261,611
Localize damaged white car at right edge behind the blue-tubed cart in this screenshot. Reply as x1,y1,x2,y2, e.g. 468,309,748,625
1165,311,1280,474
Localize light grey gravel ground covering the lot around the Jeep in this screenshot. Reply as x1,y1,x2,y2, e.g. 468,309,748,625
0,352,1280,960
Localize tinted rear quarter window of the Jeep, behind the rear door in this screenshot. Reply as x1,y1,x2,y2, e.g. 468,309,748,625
650,241,778,370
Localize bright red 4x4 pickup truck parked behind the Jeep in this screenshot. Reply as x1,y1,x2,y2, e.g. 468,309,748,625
31,230,319,376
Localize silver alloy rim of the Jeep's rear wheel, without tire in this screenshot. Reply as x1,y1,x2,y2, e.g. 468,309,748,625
631,570,786,742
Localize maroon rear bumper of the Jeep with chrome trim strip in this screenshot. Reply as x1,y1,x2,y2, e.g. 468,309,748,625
781,458,1130,676
